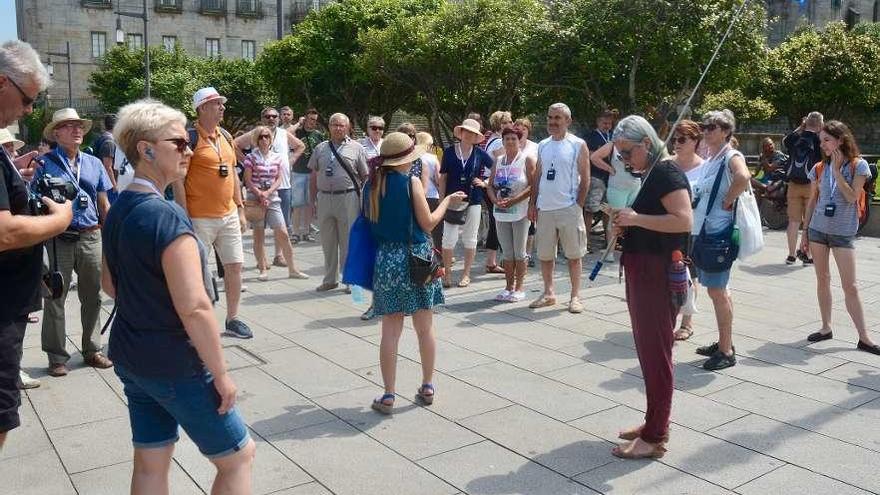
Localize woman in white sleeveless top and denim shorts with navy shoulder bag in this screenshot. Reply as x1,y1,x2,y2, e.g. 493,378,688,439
691,110,752,371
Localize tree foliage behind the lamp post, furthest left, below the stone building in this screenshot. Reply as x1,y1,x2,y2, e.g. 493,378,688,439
89,47,277,130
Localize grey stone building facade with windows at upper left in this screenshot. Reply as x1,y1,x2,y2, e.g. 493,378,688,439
16,0,329,107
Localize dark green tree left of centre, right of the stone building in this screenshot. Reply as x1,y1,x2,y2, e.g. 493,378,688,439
258,0,441,127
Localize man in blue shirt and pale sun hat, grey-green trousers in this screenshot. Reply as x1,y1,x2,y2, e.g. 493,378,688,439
31,108,113,377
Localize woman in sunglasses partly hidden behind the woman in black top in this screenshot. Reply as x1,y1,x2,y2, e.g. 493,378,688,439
672,119,703,340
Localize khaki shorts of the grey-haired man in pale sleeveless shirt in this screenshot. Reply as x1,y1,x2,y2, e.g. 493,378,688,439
535,203,587,261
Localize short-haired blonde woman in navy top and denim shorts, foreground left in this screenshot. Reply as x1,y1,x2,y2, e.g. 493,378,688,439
101,100,256,493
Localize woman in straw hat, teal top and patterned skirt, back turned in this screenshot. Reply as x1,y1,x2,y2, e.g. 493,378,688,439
363,132,466,414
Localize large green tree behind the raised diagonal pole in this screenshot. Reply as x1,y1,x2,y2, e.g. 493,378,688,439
531,0,766,123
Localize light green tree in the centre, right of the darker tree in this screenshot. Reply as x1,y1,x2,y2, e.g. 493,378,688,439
361,0,547,141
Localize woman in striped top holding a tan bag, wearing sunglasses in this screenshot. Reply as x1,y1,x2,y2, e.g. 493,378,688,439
244,126,309,282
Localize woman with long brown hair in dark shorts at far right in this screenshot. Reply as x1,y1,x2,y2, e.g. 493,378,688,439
801,120,880,355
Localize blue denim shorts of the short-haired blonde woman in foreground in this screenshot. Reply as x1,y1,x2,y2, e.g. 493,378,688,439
113,363,250,459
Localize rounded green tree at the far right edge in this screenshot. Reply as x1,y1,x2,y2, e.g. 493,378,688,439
761,22,880,123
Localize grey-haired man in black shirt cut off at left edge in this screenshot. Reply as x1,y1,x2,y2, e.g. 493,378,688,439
0,40,72,448
